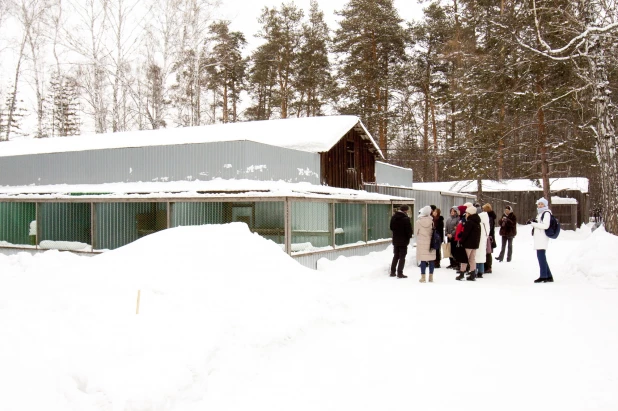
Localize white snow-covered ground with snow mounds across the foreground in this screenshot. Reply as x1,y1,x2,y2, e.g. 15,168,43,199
0,223,618,411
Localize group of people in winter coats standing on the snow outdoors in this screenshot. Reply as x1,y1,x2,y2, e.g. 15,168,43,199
390,198,553,283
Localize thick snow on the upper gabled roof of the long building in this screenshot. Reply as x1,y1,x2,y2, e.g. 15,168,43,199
0,116,384,158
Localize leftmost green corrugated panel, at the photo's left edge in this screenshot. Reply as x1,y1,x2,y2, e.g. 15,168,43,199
0,203,36,245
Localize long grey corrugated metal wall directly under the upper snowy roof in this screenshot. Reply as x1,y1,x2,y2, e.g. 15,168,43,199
0,141,321,185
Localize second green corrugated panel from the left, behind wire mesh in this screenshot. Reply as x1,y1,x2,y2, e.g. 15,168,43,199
39,203,91,244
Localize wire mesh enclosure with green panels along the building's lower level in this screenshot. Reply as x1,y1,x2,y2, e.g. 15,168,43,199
0,197,406,254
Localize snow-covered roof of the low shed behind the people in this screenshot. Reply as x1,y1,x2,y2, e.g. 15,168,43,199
414,177,588,193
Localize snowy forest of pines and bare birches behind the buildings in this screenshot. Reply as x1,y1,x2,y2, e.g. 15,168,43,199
0,0,618,233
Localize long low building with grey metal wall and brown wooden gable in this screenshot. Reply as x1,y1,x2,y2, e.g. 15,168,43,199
0,116,414,267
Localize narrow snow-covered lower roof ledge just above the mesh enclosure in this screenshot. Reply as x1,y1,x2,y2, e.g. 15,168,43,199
0,179,410,201
